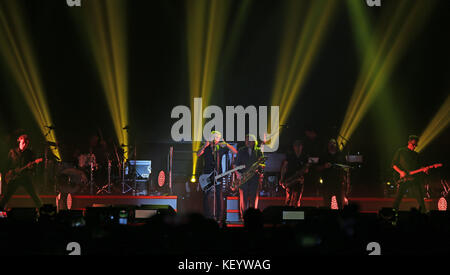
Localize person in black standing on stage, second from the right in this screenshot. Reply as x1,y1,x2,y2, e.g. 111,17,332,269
318,139,345,209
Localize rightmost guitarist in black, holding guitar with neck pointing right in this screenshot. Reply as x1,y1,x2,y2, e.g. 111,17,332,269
392,135,428,213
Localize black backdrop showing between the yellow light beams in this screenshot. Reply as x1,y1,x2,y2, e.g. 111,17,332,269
0,0,450,198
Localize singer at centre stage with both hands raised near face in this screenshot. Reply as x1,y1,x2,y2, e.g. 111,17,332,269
197,131,237,221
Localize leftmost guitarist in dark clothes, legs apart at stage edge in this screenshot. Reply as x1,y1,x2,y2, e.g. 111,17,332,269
0,135,42,210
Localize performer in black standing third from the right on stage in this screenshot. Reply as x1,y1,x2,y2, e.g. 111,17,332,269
280,140,308,207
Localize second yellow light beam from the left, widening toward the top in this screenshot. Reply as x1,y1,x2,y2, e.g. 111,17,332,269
81,0,130,159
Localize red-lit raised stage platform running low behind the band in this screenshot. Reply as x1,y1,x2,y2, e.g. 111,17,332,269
1,195,439,217
